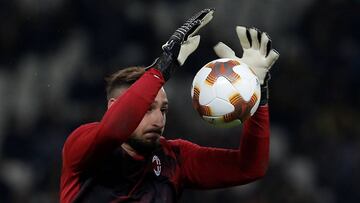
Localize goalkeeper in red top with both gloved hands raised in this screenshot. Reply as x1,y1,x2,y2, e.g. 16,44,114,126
61,9,278,203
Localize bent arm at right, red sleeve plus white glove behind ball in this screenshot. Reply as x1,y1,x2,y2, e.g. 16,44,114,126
180,26,279,188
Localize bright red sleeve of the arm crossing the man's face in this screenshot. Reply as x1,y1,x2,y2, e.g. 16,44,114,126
63,69,164,170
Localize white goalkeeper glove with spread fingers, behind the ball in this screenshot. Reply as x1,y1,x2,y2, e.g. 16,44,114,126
214,26,279,105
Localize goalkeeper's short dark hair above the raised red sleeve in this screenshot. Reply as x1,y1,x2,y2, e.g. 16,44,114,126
105,66,145,100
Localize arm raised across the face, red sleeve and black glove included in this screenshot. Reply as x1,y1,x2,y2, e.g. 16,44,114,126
63,9,213,170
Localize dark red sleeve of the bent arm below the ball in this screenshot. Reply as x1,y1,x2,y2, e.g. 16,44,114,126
174,106,269,189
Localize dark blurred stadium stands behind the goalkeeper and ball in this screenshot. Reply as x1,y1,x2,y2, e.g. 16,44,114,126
0,0,360,203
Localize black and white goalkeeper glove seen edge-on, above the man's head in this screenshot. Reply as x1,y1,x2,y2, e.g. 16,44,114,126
147,8,214,81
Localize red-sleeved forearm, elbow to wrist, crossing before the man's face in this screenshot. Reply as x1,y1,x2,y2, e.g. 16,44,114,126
98,69,164,144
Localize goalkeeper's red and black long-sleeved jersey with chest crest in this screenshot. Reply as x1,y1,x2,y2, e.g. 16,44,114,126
60,69,269,203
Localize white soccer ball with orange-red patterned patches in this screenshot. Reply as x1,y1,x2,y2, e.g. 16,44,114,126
191,58,260,127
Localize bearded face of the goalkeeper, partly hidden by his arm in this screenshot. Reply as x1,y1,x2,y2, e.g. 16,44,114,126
128,88,168,152
